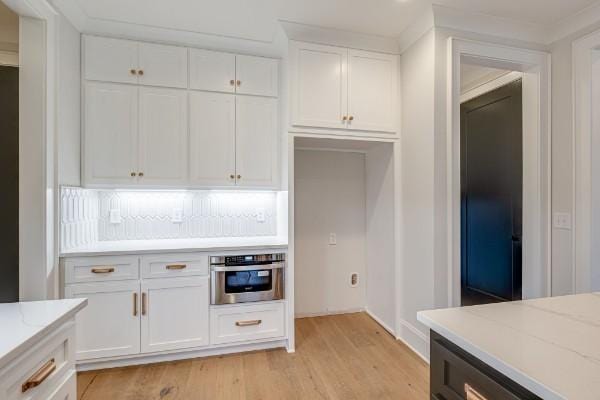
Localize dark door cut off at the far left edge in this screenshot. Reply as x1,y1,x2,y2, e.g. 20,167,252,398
0,66,19,303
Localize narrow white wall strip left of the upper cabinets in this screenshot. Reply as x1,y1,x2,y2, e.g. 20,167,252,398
56,15,81,186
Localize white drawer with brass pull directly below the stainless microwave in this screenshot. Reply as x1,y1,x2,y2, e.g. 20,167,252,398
210,302,285,344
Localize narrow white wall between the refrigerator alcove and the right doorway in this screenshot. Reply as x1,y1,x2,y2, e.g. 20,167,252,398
397,30,436,355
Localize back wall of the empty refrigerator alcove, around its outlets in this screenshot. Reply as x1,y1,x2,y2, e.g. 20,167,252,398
294,150,366,317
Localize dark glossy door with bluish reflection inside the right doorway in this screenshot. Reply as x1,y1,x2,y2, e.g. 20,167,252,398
461,80,523,305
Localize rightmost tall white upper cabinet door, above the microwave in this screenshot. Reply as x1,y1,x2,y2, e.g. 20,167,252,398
235,96,278,188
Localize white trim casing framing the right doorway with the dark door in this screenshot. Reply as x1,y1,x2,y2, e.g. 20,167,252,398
446,38,552,306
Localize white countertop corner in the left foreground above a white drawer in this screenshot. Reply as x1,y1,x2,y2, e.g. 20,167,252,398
0,299,87,368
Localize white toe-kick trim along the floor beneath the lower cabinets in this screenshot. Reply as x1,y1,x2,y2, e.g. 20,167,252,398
77,340,289,372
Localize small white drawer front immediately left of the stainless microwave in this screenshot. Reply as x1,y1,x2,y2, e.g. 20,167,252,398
140,254,208,278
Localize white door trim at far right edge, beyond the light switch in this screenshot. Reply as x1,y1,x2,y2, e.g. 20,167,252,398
572,26,600,293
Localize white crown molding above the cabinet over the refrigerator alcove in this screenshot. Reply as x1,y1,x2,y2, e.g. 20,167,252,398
279,21,398,54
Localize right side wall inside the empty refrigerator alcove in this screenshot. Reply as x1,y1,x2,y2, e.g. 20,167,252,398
366,143,396,332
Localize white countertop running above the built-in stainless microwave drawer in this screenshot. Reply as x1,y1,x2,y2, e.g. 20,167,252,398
61,236,288,257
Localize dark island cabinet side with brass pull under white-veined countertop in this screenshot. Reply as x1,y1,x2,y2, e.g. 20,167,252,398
430,331,541,400
